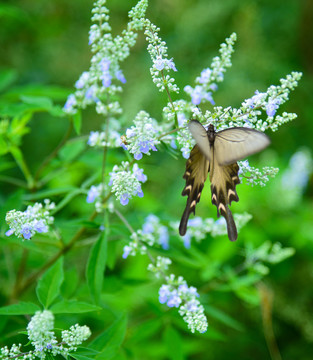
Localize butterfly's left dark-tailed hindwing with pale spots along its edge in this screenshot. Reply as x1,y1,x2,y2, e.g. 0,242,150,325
179,144,210,236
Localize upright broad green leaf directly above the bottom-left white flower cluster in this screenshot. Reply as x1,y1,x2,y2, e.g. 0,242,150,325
36,258,64,309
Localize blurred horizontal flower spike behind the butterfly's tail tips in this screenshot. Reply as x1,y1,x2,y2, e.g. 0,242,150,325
171,213,252,248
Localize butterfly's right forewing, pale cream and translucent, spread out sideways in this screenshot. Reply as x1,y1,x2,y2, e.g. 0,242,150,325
214,127,270,165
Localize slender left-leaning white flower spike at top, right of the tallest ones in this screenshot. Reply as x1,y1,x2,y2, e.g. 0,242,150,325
145,19,179,93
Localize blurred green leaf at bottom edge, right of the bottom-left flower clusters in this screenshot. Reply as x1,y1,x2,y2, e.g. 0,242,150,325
90,315,127,359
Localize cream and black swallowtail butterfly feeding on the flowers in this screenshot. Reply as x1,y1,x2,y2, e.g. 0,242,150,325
179,120,270,241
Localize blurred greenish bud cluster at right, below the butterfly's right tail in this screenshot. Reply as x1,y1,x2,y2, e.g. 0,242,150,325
244,241,295,275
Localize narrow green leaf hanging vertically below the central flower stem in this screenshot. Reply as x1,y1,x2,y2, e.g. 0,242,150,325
86,230,107,304
